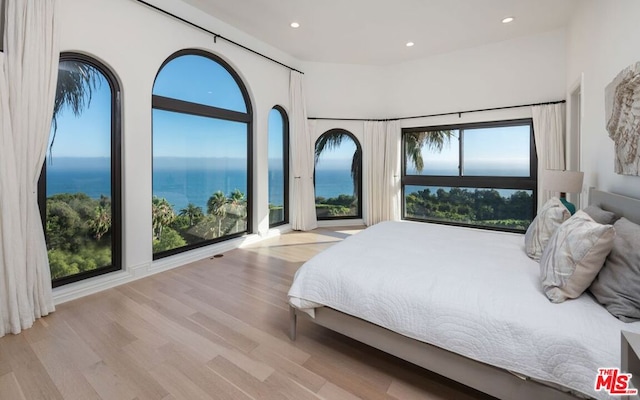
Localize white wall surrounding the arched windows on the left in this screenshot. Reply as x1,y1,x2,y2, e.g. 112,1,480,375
54,0,295,302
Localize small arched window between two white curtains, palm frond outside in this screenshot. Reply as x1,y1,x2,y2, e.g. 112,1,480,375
314,129,362,219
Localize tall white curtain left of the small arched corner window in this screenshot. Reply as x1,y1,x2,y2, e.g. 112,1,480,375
289,71,318,231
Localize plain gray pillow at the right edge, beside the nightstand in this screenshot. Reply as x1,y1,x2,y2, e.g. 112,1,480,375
589,217,640,322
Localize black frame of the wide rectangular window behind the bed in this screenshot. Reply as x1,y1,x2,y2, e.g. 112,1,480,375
401,118,538,233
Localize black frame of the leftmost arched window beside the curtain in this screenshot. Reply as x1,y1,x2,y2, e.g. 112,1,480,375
38,52,123,288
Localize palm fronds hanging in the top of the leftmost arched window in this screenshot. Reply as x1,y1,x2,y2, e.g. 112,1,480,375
49,61,101,152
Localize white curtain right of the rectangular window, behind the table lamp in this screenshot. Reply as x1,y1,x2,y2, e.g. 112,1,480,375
531,104,565,208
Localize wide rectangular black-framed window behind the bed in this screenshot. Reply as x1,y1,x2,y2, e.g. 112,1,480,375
402,119,537,232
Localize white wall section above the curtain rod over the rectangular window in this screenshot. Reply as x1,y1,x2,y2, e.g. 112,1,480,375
303,30,566,119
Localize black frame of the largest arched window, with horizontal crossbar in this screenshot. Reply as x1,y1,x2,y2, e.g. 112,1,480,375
151,49,254,260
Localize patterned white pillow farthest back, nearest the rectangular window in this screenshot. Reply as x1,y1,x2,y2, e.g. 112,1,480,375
524,197,571,261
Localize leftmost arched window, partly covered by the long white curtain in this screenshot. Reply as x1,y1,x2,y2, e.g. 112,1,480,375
39,53,121,286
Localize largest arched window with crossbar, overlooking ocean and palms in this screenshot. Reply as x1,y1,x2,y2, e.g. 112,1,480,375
152,50,252,259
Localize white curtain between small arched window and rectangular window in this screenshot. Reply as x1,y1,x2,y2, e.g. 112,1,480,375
363,121,400,226
